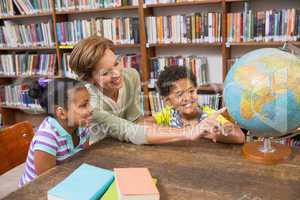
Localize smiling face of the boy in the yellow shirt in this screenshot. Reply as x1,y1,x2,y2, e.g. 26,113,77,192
165,78,199,116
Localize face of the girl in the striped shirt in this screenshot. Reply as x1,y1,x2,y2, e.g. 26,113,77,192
67,88,92,127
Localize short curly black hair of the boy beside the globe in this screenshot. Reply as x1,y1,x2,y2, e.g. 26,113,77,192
157,65,197,97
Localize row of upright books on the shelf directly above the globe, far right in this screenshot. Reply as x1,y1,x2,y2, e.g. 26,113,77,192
227,7,300,42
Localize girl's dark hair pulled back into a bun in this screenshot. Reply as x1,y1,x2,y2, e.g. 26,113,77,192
28,78,84,116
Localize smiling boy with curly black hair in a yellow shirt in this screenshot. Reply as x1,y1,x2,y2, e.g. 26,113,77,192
154,65,245,143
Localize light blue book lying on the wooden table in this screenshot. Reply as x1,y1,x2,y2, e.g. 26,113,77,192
48,163,114,200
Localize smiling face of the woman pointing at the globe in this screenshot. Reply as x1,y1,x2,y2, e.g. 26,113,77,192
92,49,124,92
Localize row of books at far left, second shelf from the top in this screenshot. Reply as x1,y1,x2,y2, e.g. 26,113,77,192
0,21,54,47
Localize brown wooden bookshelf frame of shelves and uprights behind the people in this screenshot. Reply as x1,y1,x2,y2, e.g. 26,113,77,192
0,0,300,125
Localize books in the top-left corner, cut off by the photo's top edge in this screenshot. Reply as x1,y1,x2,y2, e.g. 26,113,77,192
0,0,51,16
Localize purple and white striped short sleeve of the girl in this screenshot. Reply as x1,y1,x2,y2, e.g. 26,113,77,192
33,131,58,156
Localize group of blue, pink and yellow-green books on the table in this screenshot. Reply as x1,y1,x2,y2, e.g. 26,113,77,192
48,163,159,200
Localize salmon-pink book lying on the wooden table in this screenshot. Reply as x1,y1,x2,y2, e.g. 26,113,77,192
114,168,159,200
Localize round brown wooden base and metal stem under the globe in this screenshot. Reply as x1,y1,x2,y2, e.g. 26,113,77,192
243,138,292,165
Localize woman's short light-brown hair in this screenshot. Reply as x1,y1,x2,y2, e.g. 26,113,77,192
70,35,113,81
